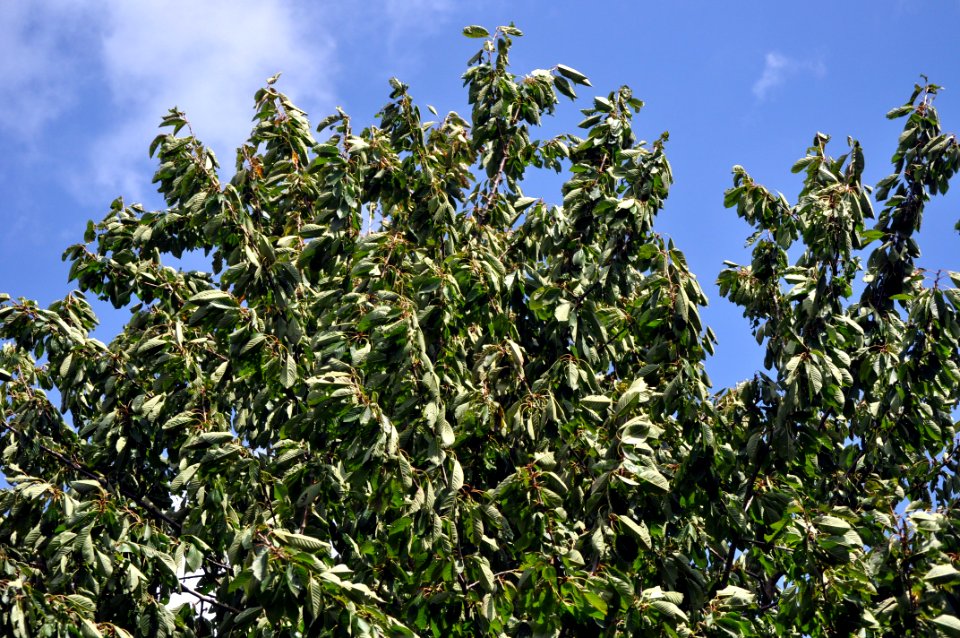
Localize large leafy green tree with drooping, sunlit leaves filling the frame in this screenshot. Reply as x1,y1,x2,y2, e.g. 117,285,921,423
0,26,960,636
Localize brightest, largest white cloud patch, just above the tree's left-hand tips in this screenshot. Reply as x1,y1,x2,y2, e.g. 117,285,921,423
92,0,334,200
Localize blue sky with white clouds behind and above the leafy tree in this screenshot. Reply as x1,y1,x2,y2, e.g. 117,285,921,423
0,0,960,389
